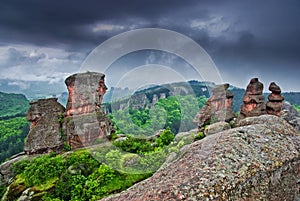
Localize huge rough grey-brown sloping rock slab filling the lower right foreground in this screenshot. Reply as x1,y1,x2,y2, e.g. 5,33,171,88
103,115,300,201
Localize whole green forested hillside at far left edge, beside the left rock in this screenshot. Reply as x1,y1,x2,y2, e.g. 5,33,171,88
0,92,29,163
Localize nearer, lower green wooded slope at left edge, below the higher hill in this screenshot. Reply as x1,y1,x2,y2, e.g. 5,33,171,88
0,117,29,163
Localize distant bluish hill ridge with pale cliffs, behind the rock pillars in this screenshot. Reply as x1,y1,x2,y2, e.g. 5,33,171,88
105,80,300,112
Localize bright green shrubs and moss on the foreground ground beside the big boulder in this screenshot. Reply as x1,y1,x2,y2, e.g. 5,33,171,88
0,125,198,201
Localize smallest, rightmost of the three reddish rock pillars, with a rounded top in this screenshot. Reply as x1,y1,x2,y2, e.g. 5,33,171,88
267,82,284,117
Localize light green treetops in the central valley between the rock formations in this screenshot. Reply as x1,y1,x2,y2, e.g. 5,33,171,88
109,95,207,136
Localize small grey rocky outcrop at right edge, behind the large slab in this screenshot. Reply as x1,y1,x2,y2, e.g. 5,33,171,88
281,101,300,132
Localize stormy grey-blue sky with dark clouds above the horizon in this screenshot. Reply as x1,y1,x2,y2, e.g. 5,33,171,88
0,0,300,91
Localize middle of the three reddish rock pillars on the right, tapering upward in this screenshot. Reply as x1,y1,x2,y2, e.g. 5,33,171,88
238,78,266,121
